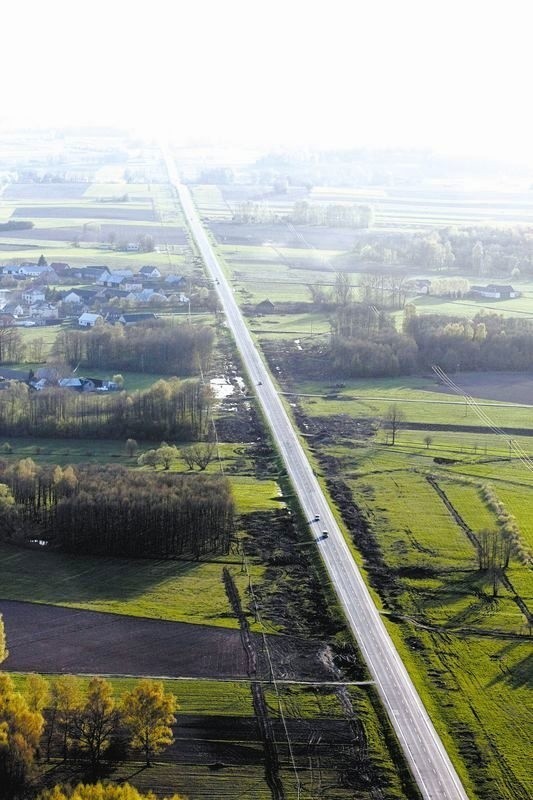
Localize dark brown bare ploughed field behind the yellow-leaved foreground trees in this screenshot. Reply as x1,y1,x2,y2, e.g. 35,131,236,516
0,600,252,678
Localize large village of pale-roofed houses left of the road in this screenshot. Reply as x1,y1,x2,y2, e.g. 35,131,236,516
0,262,189,327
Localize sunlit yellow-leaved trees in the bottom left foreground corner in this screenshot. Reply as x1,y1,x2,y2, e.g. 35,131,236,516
0,674,178,800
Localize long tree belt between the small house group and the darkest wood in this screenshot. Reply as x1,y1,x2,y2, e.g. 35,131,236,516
0,378,212,441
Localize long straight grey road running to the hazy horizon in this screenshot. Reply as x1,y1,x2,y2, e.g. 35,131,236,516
163,148,467,800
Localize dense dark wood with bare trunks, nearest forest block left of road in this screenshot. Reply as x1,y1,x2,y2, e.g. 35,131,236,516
0,458,234,559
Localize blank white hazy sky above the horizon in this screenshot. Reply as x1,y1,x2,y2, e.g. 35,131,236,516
4,0,533,162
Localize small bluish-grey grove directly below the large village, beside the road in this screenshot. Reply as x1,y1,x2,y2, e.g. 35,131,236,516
54,319,214,375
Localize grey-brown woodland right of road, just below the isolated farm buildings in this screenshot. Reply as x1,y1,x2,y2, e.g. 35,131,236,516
328,310,533,377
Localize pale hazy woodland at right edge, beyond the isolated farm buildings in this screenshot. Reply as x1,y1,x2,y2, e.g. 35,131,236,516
353,226,533,277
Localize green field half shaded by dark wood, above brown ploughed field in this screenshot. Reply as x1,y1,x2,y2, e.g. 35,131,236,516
0,544,263,628
